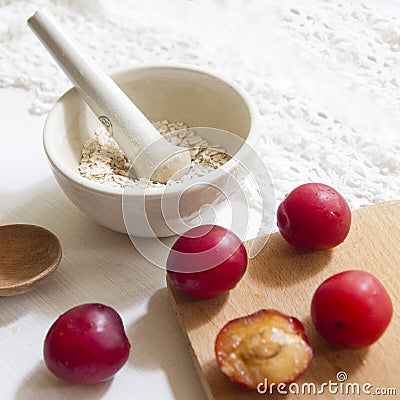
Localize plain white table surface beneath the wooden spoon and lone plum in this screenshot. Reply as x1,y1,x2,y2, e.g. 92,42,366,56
0,89,204,400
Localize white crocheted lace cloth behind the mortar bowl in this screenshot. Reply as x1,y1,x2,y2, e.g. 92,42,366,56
0,0,400,231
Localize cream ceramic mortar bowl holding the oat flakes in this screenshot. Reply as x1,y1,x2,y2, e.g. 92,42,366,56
43,65,260,237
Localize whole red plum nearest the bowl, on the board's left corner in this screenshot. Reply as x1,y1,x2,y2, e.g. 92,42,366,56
167,225,247,298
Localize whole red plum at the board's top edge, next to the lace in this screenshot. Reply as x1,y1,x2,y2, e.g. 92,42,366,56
277,183,351,250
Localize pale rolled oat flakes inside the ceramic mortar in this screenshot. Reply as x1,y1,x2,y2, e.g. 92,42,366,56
79,120,230,188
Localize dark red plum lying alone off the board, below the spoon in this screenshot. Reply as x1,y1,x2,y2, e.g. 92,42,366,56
43,304,130,384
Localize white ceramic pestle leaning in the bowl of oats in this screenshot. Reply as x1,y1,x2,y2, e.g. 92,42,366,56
28,10,190,182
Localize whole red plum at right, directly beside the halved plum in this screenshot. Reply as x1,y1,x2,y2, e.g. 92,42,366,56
311,270,393,349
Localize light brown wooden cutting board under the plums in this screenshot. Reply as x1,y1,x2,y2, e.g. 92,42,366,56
168,201,400,400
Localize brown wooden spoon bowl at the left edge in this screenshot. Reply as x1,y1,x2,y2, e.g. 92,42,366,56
0,224,62,296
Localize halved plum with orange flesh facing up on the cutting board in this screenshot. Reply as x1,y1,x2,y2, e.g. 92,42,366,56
215,310,313,390
